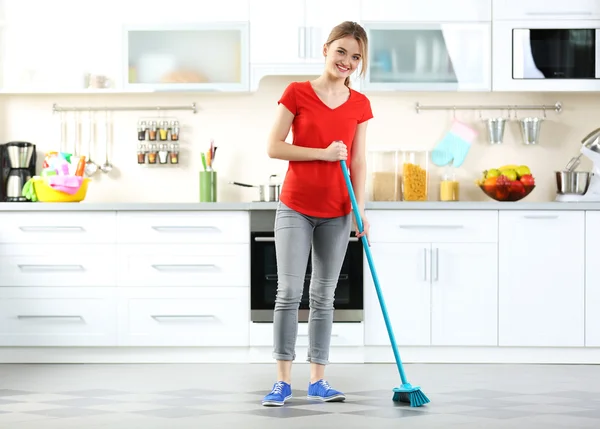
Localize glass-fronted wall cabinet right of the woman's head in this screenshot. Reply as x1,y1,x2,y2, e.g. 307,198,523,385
364,23,491,91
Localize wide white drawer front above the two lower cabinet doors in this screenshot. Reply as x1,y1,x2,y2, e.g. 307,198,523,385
366,210,498,243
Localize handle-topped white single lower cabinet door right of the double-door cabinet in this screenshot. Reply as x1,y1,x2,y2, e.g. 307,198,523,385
499,211,585,347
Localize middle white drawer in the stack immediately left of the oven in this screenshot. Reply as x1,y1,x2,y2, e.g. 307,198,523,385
118,244,250,287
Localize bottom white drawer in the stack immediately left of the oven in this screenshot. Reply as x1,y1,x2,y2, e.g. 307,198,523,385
120,288,250,347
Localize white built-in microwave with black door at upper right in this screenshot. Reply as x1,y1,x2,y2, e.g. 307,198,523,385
493,20,600,91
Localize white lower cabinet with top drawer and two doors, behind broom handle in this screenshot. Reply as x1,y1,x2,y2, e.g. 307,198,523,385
365,211,498,346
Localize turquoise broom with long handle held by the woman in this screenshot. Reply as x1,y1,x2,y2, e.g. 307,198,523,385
341,160,429,407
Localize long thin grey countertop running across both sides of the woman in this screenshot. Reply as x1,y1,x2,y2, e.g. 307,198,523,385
0,201,600,212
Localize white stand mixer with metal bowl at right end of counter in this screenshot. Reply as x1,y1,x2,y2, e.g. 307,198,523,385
555,128,600,202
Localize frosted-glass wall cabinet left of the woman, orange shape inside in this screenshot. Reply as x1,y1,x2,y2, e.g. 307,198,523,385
123,22,250,91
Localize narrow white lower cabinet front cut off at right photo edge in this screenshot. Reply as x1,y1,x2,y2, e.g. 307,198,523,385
585,212,600,347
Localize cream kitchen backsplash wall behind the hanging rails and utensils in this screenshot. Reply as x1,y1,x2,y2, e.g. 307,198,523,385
0,76,600,202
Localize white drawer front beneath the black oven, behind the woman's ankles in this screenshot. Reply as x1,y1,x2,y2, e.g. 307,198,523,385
250,323,365,347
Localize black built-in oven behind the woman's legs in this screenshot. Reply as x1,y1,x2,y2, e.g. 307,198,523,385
250,231,364,322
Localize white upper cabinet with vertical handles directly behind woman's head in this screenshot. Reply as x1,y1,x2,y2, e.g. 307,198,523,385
250,0,360,90
